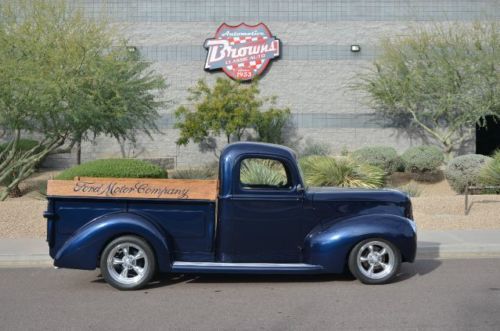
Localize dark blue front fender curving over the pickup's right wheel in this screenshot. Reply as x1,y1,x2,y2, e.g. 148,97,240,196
303,214,417,273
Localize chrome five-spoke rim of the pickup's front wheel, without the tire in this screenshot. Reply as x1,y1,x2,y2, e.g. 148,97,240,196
357,241,395,279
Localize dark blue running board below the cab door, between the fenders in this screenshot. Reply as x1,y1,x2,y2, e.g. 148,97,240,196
172,261,323,274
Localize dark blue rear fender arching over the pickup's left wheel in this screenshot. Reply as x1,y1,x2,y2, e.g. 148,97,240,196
54,213,172,272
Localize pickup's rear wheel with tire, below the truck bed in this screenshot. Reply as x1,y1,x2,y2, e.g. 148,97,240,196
100,236,156,290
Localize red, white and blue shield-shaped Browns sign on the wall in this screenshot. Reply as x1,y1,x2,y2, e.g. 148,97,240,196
205,23,280,80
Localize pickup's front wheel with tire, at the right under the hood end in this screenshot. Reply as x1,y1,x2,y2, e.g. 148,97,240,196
349,239,401,284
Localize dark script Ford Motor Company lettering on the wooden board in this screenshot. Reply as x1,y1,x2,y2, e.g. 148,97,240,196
73,182,189,199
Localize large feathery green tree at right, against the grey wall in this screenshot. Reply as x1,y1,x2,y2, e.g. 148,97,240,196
357,21,500,159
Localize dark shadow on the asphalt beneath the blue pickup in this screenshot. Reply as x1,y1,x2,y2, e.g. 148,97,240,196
135,260,441,289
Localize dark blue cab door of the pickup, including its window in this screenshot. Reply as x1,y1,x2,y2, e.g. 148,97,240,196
218,155,304,263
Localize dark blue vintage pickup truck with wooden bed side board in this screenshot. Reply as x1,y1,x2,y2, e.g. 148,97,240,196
44,143,417,290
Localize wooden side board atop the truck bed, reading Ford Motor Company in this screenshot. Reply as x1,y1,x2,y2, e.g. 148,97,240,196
47,177,218,201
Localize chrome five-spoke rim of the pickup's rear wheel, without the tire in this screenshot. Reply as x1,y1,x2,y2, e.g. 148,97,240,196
107,243,149,284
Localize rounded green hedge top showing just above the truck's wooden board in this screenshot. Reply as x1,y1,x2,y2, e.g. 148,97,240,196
56,159,167,179
